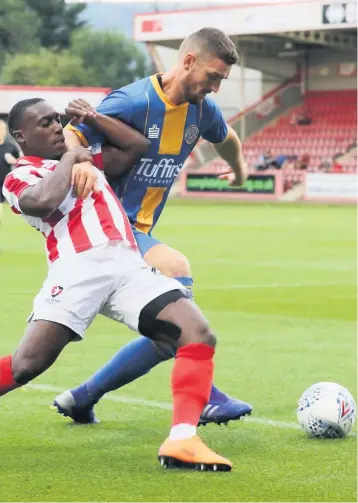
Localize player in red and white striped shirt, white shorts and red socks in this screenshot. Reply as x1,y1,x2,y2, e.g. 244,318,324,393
0,99,231,471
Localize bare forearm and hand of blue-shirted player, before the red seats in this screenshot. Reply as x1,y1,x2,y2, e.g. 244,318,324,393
214,126,248,185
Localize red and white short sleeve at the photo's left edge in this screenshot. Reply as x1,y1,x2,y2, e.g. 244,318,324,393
2,166,42,214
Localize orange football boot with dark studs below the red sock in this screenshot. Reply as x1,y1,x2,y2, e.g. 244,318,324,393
158,436,232,472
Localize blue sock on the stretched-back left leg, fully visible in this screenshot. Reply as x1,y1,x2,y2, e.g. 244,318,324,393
71,337,174,407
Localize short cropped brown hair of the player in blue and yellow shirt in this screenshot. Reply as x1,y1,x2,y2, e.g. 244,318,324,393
180,28,239,65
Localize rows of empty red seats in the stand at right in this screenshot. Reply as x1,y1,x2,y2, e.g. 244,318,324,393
244,90,357,172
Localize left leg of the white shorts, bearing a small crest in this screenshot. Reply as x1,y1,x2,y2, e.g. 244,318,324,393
32,252,115,340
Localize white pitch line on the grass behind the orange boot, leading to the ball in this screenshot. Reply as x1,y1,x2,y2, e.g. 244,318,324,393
25,383,300,430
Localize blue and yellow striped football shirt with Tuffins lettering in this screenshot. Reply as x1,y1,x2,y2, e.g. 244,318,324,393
67,75,228,234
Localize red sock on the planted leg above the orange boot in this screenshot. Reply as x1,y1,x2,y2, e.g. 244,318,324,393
172,344,214,426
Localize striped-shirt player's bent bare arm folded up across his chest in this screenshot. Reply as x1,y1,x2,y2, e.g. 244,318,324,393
19,147,92,218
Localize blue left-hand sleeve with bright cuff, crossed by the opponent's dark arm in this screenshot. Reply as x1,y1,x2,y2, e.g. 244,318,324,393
66,91,133,147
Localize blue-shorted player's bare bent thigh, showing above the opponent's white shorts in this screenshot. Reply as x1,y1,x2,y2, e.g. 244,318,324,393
133,228,191,278
